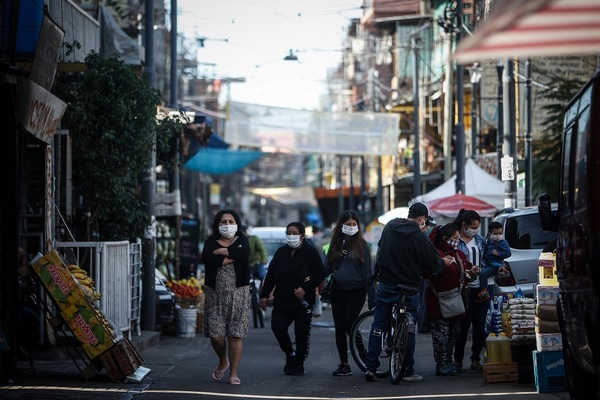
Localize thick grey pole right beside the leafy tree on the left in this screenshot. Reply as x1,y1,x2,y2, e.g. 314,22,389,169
140,0,156,331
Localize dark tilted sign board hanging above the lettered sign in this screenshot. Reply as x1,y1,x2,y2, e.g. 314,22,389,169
29,15,65,90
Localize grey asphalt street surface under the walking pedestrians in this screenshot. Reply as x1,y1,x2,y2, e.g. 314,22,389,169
0,309,569,400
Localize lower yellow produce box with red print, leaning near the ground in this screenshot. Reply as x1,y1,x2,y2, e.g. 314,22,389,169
60,299,123,359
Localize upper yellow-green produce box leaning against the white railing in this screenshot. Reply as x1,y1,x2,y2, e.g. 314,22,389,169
31,250,85,311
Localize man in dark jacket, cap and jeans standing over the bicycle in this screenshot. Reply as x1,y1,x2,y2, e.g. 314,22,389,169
365,203,453,382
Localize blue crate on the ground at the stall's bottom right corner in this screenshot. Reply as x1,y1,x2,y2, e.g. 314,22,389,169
533,351,568,393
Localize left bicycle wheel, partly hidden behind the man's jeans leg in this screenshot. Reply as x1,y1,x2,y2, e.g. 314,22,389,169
350,310,389,378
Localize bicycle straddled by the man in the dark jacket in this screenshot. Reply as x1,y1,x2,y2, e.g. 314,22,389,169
350,285,418,384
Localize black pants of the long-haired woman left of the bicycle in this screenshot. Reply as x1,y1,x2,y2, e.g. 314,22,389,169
331,288,367,364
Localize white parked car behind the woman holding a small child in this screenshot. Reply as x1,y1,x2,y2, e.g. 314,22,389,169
495,207,556,297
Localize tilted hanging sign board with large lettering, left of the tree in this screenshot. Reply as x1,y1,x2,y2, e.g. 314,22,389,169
18,78,67,144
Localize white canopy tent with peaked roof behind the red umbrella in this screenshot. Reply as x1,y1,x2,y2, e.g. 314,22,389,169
416,159,525,210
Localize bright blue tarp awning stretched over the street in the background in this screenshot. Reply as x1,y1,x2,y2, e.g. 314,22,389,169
183,147,265,175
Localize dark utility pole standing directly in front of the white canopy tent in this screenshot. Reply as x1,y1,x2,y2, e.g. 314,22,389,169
455,0,465,194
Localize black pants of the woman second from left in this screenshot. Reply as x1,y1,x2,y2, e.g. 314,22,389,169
271,307,312,365
